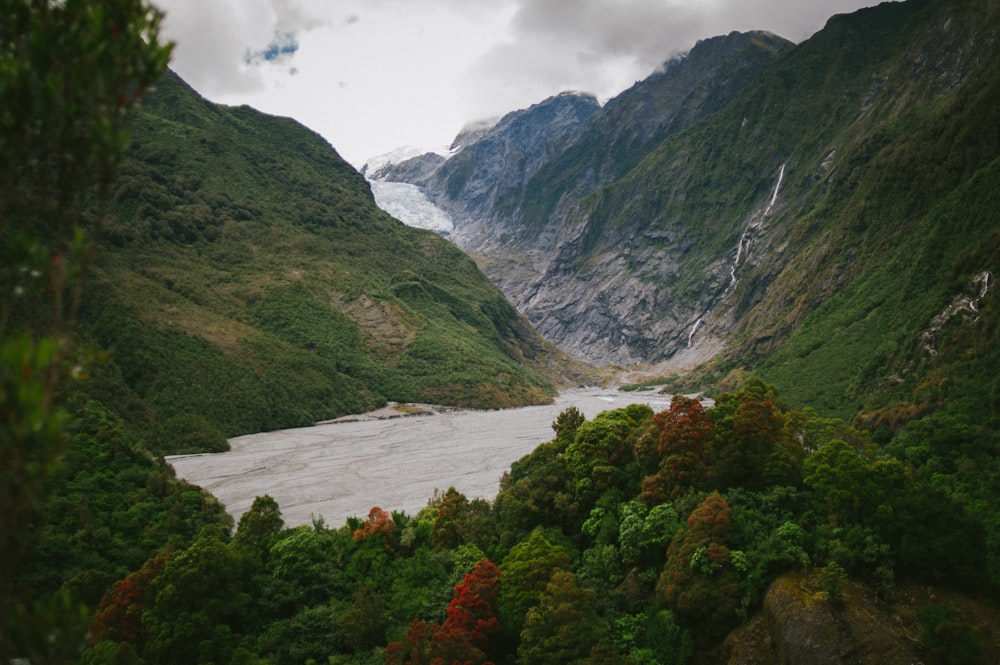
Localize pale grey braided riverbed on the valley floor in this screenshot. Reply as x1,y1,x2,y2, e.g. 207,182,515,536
167,388,670,527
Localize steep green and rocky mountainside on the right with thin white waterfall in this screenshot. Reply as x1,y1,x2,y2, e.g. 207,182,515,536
378,0,1000,416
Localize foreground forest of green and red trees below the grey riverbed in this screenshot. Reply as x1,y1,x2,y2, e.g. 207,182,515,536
15,377,1000,664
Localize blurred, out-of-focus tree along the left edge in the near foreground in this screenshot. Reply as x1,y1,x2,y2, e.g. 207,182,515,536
0,0,170,662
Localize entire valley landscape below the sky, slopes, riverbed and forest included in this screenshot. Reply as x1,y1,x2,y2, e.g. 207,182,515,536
0,0,1000,665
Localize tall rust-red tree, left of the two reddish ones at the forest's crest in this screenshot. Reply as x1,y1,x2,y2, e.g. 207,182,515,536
642,395,715,504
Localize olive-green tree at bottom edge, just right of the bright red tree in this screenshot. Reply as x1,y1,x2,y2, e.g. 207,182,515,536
517,570,608,665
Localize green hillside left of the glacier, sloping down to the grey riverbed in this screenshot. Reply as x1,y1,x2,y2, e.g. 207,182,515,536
81,75,550,451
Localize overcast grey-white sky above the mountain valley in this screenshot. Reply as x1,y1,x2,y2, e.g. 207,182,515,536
153,0,877,167
